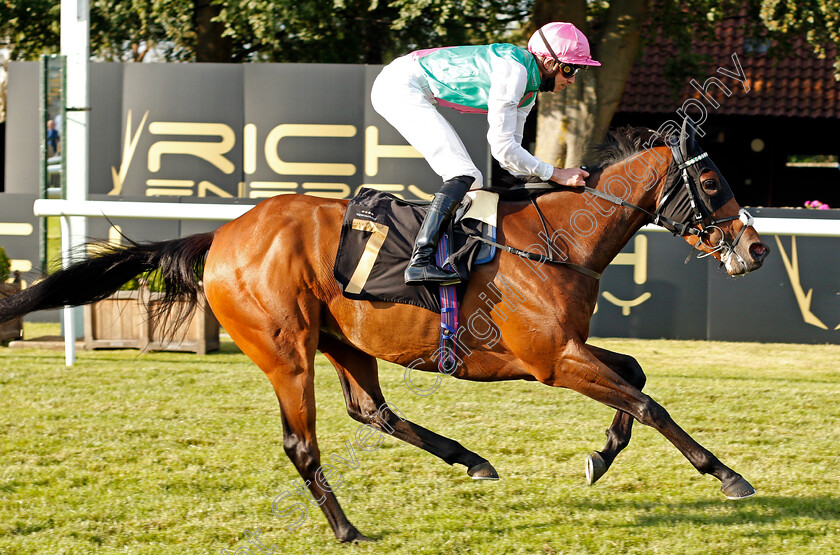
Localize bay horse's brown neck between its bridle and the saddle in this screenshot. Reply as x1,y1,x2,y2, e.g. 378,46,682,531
546,147,671,272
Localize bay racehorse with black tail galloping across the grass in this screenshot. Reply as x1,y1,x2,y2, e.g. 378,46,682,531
0,126,769,542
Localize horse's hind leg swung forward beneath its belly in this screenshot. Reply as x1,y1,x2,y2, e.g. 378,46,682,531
318,334,499,480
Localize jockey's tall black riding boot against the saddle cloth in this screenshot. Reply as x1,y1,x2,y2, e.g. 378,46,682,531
404,176,475,285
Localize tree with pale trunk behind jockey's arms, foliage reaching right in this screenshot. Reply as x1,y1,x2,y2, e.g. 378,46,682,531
527,0,840,167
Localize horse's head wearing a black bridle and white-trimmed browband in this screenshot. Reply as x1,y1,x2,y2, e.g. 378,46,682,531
657,120,770,276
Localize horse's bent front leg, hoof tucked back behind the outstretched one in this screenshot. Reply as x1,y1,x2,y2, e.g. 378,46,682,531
586,345,645,485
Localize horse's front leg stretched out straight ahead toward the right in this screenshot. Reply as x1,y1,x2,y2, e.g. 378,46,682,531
535,342,755,499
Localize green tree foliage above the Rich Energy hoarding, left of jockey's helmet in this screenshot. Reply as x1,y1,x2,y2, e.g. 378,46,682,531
0,0,533,64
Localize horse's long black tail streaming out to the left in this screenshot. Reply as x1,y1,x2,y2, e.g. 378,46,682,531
0,232,215,330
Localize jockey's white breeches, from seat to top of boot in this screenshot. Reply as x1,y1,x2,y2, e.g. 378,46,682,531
370,56,482,189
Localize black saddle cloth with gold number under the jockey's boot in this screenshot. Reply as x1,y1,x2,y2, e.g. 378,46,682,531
333,188,499,313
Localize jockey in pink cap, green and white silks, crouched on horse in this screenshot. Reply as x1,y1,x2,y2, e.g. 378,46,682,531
371,22,601,285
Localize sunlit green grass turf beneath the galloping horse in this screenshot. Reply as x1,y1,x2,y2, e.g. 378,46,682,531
0,324,840,554
